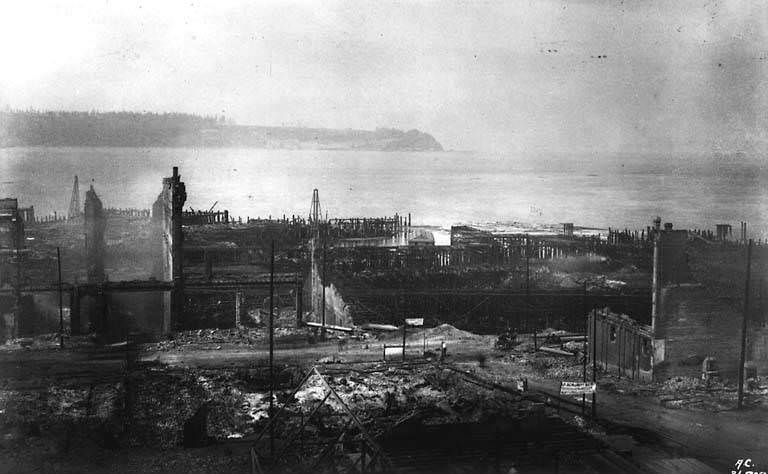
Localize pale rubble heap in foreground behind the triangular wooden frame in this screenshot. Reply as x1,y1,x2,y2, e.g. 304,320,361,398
252,365,532,458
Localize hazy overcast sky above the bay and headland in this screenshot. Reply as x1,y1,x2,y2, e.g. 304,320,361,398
0,0,768,152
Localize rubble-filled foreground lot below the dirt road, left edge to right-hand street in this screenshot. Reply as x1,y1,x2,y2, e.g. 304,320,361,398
0,354,540,472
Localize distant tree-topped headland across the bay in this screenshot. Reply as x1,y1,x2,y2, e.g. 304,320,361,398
0,111,443,151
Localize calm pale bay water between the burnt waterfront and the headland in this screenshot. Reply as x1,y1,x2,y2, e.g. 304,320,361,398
0,148,768,238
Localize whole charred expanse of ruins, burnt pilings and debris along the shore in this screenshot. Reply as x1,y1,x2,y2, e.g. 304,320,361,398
0,168,768,472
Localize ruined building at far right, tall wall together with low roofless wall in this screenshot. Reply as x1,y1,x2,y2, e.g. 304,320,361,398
588,218,768,380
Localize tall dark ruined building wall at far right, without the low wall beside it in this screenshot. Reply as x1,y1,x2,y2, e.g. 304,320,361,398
653,224,768,380
